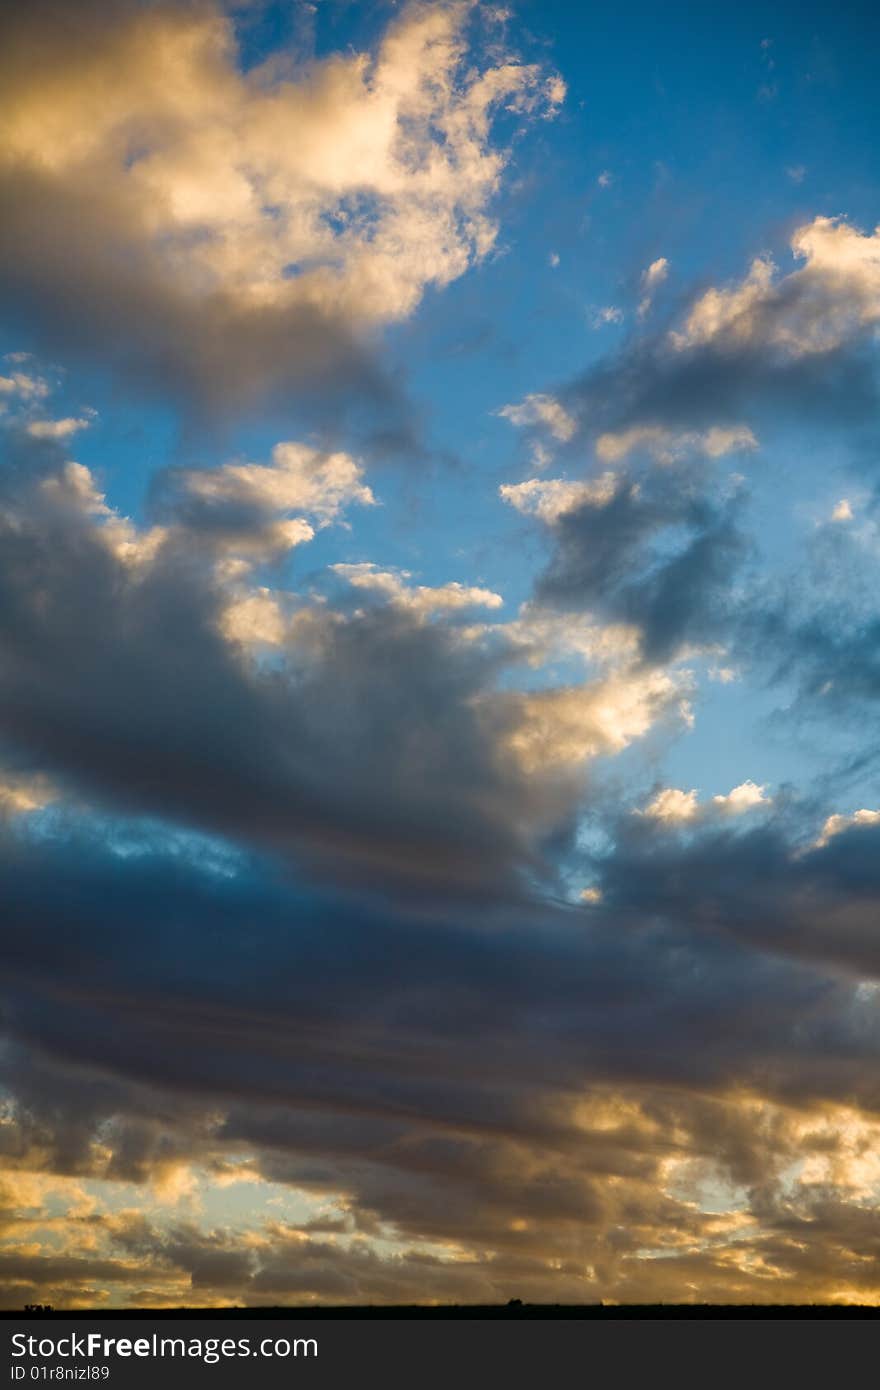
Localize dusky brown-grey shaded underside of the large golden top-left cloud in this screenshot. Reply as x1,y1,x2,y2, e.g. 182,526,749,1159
0,160,394,430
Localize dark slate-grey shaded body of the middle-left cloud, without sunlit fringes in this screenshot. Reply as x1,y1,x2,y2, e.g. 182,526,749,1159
0,450,561,891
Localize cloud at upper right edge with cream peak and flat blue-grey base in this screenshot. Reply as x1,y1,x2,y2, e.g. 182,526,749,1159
550,218,877,472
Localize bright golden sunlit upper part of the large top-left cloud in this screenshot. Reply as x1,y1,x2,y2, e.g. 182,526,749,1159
0,3,564,327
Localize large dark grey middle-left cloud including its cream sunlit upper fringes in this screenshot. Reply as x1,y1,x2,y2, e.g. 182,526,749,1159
0,442,653,894
